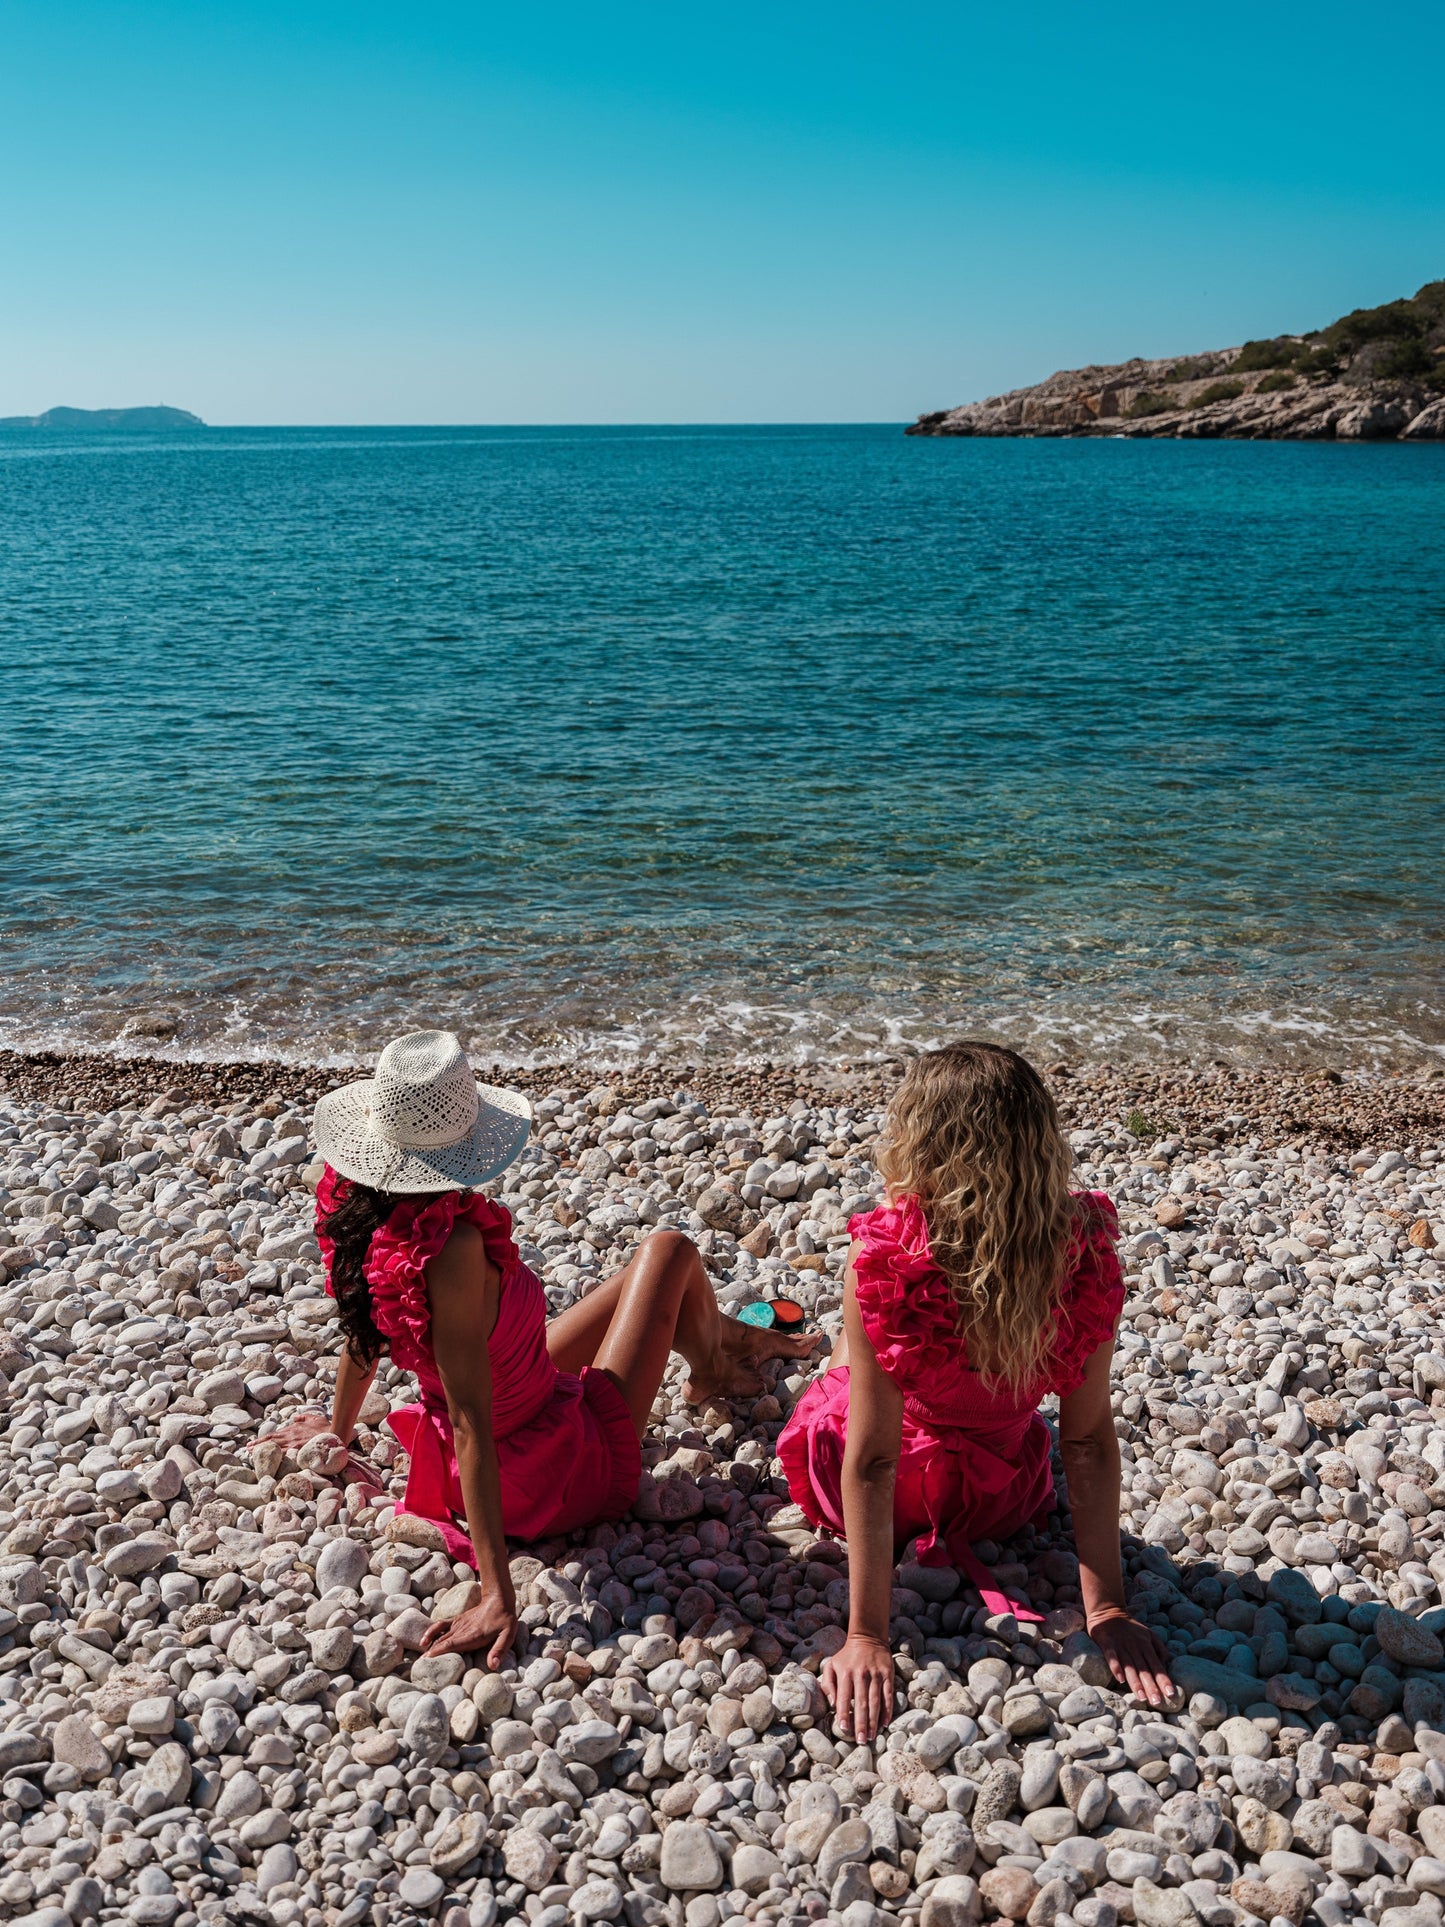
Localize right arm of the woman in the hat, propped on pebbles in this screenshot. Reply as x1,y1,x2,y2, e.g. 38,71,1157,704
412,1226,516,1673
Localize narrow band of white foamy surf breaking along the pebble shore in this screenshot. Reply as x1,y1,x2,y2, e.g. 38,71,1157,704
0,979,1445,1077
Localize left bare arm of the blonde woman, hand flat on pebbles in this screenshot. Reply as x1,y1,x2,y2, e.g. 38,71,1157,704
821,1262,904,1744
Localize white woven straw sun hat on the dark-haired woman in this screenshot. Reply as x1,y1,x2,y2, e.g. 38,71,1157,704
314,1031,532,1191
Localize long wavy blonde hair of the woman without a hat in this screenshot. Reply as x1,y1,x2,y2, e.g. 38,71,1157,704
879,1043,1089,1393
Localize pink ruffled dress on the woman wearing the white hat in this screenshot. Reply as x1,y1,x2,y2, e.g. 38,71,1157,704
316,1166,642,1565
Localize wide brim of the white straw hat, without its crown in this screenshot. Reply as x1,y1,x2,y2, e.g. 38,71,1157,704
312,1077,532,1193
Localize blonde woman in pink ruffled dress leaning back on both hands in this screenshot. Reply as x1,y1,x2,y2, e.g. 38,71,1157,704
778,1044,1173,1742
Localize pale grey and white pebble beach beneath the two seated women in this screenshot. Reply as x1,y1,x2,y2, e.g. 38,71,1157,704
0,1054,1445,1927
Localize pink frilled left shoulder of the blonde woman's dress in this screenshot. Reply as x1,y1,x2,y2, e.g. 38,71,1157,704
848,1197,961,1387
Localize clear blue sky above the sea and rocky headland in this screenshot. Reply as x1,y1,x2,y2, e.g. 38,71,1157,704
0,0,1445,422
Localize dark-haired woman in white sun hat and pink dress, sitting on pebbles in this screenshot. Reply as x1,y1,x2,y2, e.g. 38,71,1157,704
277,1031,815,1669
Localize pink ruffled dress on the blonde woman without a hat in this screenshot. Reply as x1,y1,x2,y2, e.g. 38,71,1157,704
778,1191,1123,1619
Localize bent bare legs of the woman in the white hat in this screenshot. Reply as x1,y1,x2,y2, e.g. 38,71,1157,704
547,1231,817,1438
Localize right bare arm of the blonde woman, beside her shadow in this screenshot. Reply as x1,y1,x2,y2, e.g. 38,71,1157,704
1058,1339,1173,1705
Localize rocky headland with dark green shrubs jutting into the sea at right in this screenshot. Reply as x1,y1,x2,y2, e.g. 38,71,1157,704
906,281,1445,441
